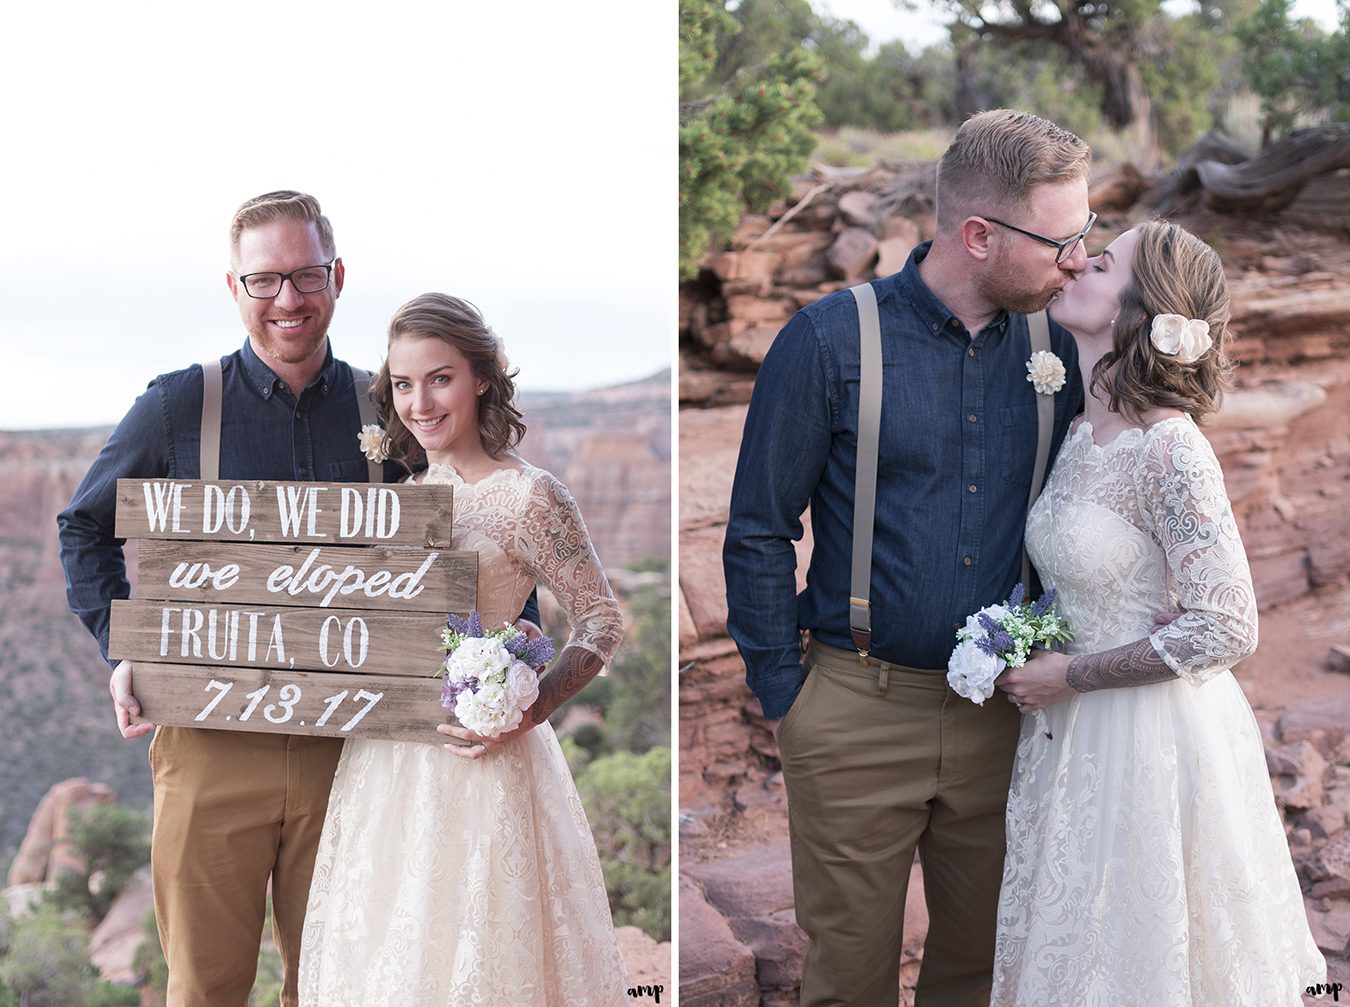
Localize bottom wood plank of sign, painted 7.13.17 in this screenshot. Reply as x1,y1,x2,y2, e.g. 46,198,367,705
132,664,454,739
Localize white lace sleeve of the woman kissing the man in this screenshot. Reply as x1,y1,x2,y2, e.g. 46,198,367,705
1135,423,1257,686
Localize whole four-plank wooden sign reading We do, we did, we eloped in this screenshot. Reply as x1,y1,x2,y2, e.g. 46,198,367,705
108,479,478,741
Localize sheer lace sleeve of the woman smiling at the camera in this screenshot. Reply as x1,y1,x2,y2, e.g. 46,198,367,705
517,472,624,664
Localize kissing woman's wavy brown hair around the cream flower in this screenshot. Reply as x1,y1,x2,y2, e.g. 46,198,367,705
1091,220,1233,421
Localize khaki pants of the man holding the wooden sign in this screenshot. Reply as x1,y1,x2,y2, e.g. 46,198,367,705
150,728,342,1007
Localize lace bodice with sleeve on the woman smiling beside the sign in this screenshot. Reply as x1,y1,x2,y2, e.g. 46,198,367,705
425,464,624,664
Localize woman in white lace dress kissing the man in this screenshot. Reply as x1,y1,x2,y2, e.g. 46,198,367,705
992,215,1326,1007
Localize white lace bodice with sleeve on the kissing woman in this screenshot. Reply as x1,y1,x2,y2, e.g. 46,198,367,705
1026,416,1257,686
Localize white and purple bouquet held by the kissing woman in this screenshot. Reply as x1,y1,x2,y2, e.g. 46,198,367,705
946,583,1073,734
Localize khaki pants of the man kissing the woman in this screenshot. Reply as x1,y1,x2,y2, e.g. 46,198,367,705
779,641,1021,1007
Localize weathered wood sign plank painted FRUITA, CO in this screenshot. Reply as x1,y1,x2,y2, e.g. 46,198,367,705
108,599,448,675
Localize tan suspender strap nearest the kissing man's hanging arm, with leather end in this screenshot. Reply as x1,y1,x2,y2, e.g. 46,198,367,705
848,283,882,659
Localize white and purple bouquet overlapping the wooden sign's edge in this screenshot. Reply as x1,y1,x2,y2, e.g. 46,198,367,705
436,611,554,738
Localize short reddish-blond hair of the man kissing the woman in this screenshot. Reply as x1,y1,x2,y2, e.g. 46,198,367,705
937,108,1092,231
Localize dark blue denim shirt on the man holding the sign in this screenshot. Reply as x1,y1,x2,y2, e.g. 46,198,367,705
57,342,402,659
